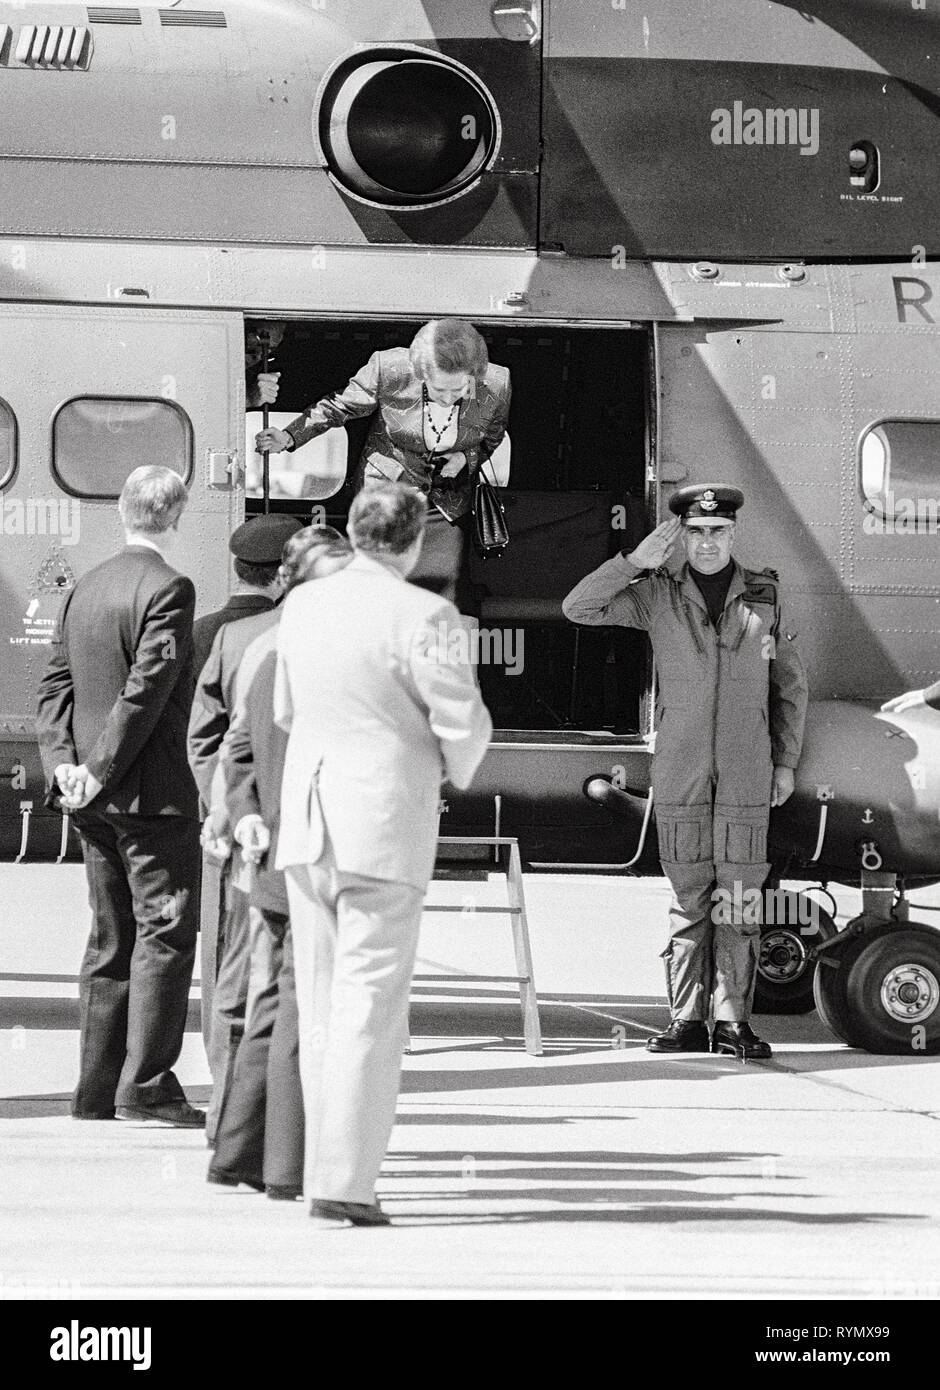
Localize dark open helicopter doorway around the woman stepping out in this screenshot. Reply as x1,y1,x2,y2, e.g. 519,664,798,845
246,320,649,738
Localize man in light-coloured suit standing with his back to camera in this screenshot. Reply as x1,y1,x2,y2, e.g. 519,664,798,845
274,484,492,1226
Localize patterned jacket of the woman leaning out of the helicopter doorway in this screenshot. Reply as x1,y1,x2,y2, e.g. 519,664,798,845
286,348,512,521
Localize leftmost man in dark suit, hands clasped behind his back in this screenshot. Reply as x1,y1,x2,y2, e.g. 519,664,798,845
36,467,204,1129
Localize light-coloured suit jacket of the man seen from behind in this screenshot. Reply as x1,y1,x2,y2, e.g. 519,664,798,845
274,553,492,890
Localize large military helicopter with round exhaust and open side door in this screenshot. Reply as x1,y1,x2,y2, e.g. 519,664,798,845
0,0,940,1052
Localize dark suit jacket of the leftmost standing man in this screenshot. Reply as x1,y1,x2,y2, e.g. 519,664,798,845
36,545,196,817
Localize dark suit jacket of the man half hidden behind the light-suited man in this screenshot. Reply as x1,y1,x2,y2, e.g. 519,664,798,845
211,609,288,915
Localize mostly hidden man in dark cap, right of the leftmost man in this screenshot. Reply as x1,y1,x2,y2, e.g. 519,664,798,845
188,514,300,1143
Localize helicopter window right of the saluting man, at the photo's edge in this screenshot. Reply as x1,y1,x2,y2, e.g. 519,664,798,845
858,420,940,527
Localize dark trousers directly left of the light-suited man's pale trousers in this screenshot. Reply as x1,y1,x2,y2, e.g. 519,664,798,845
211,908,303,1188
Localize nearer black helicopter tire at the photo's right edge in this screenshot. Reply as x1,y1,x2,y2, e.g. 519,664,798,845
844,922,940,1056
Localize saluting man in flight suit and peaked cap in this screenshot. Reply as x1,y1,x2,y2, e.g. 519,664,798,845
563,484,807,1058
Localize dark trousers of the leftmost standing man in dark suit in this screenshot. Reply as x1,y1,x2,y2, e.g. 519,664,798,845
72,810,200,1118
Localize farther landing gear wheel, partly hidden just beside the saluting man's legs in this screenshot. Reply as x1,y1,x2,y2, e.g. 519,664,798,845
754,890,837,1013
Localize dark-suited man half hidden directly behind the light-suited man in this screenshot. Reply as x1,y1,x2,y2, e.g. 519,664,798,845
209,525,352,1200
